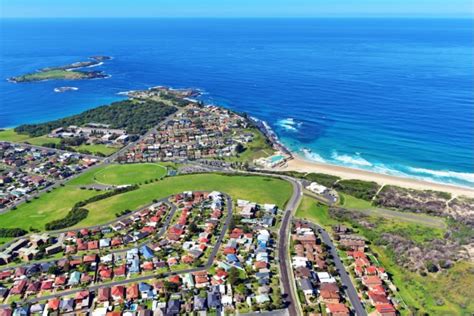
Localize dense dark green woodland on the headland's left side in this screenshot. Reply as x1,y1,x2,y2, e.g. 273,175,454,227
15,100,177,137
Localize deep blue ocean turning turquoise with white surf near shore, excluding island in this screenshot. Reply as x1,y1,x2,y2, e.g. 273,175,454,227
0,19,474,187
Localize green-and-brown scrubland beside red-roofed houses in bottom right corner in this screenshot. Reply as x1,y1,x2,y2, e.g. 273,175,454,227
296,195,474,315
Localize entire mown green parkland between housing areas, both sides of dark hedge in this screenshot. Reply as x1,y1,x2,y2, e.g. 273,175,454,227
0,164,292,230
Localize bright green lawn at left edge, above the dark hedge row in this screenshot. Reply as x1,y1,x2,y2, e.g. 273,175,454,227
0,186,100,230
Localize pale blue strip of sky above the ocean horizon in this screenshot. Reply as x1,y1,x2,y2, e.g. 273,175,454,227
0,0,474,18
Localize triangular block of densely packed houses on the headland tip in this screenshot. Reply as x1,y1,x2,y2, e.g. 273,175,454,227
119,102,254,162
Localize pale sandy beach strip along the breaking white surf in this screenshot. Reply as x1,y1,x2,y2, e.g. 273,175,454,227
277,156,474,197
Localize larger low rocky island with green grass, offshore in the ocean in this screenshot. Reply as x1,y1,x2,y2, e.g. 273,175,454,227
8,56,111,83
